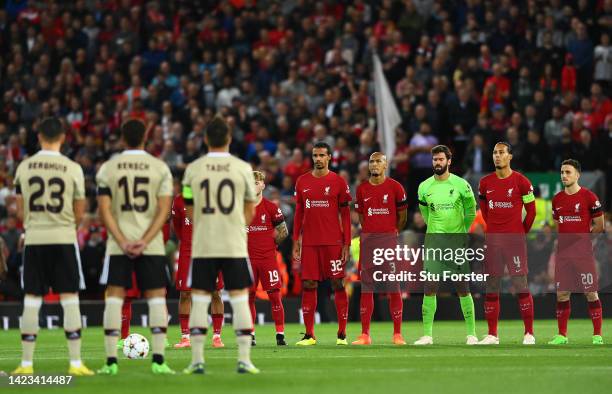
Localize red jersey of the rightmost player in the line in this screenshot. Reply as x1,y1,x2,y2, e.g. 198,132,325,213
552,187,603,259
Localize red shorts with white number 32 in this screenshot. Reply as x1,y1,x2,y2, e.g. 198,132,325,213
301,245,346,281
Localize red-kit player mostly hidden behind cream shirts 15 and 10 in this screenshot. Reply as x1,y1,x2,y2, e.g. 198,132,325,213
172,194,225,349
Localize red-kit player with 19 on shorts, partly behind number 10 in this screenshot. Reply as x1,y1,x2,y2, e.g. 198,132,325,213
247,171,289,346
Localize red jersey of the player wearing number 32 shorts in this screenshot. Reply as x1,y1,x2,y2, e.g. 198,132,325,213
293,171,351,246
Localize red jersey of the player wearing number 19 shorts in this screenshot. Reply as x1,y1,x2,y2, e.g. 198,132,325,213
247,198,285,260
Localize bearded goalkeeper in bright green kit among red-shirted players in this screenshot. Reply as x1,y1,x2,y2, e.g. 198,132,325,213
414,145,478,345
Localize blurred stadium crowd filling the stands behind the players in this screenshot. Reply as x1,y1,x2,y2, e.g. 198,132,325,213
0,0,612,296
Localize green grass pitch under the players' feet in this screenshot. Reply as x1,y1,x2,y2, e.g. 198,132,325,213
0,320,612,394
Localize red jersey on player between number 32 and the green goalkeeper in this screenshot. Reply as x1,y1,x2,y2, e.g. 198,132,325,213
355,178,406,234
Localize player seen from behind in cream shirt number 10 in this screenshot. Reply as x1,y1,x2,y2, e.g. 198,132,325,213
183,116,259,374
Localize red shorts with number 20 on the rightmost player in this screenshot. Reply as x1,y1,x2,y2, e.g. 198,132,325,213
555,255,599,293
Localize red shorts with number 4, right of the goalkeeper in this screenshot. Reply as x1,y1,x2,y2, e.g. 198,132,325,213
485,234,529,276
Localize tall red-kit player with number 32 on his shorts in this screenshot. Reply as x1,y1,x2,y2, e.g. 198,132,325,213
292,142,351,346
